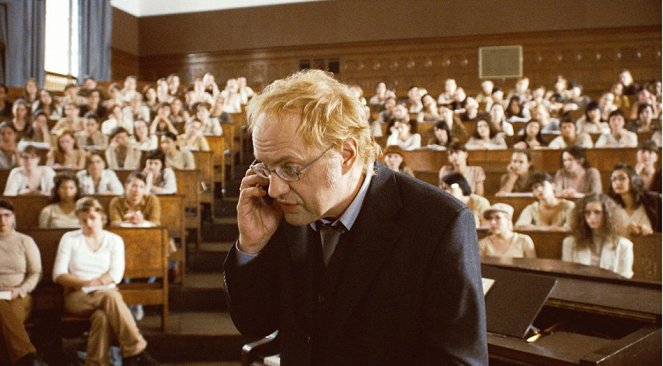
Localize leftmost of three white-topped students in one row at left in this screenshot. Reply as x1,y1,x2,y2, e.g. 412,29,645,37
4,146,55,196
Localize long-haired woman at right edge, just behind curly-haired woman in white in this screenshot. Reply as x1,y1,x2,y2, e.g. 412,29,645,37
608,163,661,235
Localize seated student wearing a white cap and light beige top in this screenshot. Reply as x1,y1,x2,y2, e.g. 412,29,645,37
479,203,536,258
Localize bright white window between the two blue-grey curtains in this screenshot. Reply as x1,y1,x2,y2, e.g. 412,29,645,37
44,0,78,76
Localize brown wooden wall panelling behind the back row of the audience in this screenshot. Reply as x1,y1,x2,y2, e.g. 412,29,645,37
137,27,661,95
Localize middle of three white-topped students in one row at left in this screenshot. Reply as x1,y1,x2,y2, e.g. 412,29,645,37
76,151,124,195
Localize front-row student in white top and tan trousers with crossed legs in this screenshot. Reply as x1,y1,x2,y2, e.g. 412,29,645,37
53,197,158,365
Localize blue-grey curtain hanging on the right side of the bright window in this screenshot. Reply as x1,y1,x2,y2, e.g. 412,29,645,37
78,0,113,82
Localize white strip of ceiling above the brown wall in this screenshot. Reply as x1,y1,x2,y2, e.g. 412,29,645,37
111,0,324,17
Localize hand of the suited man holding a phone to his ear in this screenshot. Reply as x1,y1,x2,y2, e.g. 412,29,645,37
237,168,283,254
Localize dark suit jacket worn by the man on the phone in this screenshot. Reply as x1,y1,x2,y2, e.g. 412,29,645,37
225,165,488,366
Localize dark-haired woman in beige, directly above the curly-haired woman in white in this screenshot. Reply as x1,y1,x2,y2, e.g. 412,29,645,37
554,146,603,199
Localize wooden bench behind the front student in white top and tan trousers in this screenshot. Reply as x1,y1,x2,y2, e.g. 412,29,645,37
21,227,168,333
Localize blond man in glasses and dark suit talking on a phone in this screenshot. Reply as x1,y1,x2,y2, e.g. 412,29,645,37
225,71,488,365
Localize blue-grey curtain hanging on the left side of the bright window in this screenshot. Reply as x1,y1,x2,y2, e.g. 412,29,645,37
0,0,46,87
